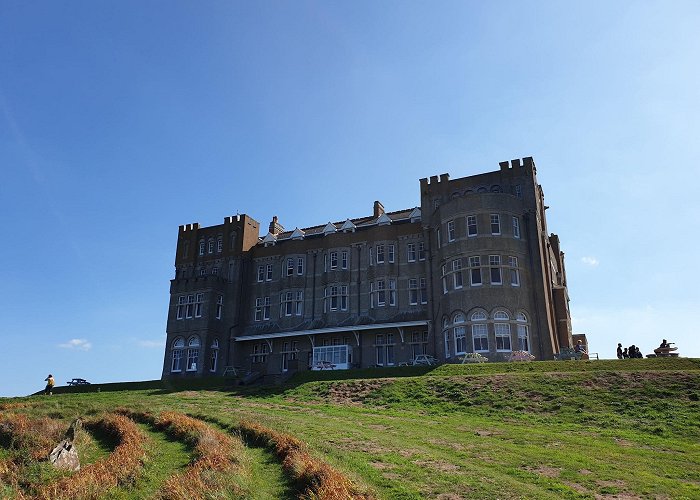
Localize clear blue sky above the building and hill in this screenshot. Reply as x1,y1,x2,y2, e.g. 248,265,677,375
0,0,700,396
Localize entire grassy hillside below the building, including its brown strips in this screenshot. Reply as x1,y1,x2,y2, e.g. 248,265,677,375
0,359,700,499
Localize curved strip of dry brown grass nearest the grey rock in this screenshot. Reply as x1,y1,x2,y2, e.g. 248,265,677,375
36,414,146,500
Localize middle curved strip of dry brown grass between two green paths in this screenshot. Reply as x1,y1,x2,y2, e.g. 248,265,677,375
122,410,246,500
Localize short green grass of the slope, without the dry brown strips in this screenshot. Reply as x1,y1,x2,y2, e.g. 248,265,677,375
5,359,700,499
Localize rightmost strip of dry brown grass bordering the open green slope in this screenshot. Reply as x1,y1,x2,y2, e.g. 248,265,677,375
240,421,373,500
